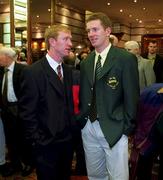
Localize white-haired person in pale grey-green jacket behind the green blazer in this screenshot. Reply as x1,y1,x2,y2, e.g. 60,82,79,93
124,41,156,90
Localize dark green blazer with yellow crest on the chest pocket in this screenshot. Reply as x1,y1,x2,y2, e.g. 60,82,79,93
80,46,139,147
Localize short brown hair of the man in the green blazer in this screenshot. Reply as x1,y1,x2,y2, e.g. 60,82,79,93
86,12,112,29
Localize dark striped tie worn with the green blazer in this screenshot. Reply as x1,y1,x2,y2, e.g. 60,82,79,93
89,55,101,122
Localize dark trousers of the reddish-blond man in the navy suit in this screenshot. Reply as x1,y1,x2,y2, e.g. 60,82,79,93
34,141,72,180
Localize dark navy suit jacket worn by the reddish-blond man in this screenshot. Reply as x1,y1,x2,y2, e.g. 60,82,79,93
19,57,73,145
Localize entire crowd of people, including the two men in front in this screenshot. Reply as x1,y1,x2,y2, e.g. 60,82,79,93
0,12,163,180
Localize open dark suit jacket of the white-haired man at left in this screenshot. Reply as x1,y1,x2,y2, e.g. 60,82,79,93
0,62,25,105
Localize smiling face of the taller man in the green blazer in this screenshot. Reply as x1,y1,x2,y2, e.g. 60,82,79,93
86,19,111,53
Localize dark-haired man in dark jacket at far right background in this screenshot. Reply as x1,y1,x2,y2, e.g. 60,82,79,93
142,40,163,83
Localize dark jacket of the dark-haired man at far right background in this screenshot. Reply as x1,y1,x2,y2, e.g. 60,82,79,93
143,54,163,83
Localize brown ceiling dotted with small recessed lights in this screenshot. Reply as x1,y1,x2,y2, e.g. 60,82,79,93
31,0,163,26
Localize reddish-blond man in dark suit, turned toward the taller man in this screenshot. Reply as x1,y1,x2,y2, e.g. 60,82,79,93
19,25,74,180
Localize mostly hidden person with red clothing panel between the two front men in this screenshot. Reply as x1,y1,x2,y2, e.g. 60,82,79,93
64,53,87,176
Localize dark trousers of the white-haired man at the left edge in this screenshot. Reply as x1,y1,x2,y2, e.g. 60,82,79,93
2,106,33,170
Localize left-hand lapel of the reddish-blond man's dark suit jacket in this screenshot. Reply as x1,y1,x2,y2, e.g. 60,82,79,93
42,58,64,96
